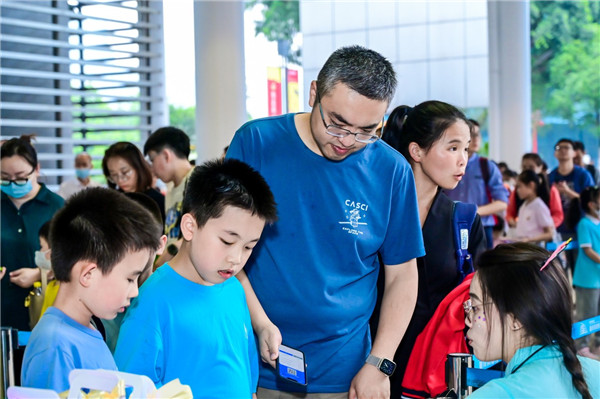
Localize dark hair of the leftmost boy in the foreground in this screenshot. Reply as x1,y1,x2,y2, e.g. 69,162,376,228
50,187,162,282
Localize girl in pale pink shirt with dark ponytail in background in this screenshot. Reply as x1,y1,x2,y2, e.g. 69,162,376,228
516,170,554,243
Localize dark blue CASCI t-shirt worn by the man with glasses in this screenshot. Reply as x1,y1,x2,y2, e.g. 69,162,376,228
227,114,425,393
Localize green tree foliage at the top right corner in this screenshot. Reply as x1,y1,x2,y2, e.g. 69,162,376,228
531,1,600,130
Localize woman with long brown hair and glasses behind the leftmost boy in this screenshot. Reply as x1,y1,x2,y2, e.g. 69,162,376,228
102,141,165,223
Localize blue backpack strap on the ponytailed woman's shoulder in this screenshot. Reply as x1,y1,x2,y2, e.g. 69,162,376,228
452,201,477,284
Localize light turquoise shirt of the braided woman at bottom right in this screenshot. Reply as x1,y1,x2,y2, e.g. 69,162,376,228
469,345,600,399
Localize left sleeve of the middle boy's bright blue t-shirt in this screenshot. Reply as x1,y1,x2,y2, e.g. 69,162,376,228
115,306,163,387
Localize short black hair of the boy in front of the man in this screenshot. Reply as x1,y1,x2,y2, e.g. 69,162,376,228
182,159,277,227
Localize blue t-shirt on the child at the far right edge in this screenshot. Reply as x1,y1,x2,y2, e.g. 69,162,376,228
573,216,600,288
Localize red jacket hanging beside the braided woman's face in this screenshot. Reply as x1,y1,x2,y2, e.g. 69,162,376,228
402,273,473,398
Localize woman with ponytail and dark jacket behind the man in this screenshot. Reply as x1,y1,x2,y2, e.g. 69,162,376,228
383,101,486,398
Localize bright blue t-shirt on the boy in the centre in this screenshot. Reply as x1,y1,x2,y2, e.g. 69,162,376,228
115,264,258,399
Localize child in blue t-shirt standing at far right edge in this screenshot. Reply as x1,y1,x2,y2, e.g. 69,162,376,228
569,187,600,356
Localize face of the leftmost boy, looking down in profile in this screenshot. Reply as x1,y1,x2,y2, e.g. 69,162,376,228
85,250,154,320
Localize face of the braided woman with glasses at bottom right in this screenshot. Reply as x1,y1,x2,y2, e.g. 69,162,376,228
465,273,504,361
